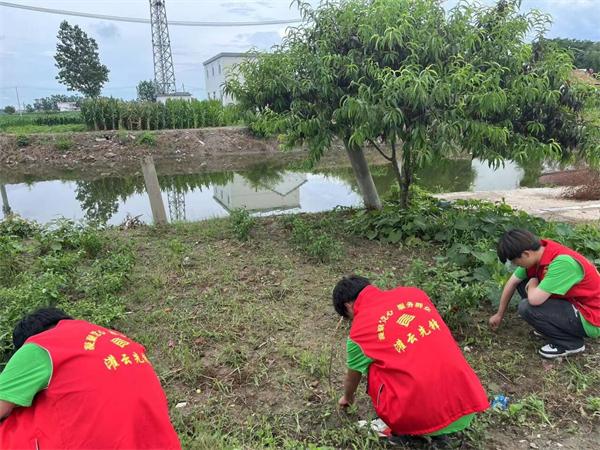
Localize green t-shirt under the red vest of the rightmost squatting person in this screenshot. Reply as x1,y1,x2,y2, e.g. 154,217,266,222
513,255,600,337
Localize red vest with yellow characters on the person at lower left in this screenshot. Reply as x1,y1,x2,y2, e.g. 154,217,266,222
0,320,181,450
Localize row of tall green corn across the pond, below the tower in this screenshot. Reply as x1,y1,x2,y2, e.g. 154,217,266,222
81,98,240,130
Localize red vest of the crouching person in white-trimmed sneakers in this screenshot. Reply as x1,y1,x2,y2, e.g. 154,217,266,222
527,239,600,327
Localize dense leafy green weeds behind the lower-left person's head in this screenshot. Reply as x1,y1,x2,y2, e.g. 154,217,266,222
0,218,134,359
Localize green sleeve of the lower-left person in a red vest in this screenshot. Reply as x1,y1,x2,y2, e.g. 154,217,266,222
0,344,52,406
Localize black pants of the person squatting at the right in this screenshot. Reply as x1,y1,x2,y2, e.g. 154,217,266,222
517,280,586,350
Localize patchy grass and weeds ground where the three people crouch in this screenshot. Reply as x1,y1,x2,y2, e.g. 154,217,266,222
0,212,600,449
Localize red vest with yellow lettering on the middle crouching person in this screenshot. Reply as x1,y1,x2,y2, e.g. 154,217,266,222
350,286,489,435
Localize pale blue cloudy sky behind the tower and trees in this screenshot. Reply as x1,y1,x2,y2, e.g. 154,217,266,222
0,0,600,106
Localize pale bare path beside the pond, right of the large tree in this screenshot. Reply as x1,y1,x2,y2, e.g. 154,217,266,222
436,188,600,222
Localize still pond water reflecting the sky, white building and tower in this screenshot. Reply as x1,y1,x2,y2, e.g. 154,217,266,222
0,156,539,224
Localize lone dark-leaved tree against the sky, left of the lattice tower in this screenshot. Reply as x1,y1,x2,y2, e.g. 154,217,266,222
54,21,109,97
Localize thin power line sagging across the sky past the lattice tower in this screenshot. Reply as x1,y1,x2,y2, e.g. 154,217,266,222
0,2,301,27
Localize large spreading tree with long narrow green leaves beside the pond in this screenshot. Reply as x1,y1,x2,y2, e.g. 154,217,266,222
227,0,599,206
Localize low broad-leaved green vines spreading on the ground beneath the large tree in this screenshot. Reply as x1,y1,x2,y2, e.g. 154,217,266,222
348,188,600,326
